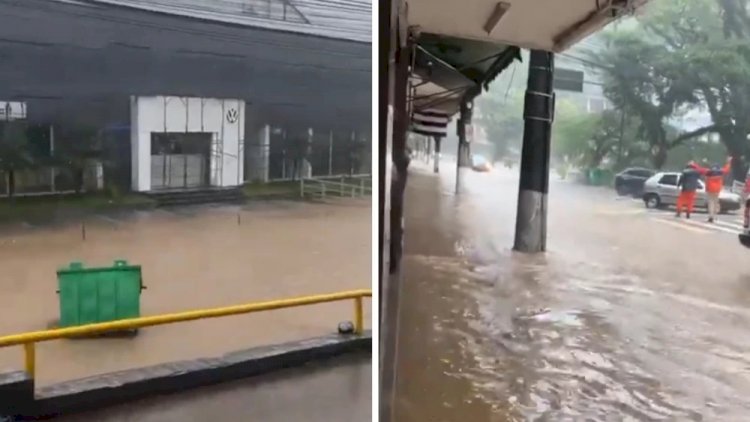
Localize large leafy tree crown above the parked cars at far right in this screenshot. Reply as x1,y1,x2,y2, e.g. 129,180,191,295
599,0,750,177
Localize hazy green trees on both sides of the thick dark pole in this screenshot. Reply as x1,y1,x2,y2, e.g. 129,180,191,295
477,0,750,178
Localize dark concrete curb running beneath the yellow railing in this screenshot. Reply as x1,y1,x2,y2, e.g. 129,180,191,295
0,331,372,420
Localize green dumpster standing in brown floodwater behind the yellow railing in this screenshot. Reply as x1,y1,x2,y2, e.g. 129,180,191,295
57,260,144,327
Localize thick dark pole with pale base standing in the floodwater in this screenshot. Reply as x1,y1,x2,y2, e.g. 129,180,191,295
513,50,555,253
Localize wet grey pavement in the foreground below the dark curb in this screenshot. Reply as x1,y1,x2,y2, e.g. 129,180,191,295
55,357,372,422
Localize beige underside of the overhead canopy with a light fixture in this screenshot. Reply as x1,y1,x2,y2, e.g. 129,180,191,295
407,0,648,52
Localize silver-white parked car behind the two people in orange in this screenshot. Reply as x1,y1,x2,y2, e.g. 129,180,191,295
643,172,742,213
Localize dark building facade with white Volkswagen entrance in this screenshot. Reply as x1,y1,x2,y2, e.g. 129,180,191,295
0,0,372,194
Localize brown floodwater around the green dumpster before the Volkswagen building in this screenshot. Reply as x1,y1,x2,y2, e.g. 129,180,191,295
0,200,372,385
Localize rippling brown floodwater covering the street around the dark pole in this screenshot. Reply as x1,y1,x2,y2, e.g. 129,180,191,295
395,163,750,422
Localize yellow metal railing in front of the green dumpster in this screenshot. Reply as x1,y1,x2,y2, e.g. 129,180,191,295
0,289,372,378
